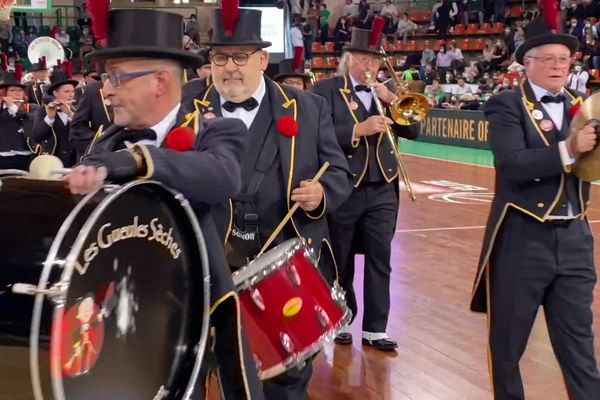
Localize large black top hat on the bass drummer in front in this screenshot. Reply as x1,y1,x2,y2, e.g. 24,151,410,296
85,9,199,67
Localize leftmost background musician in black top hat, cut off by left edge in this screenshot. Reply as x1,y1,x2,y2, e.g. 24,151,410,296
0,72,35,171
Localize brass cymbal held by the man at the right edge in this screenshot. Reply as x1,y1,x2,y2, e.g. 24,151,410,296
570,92,600,182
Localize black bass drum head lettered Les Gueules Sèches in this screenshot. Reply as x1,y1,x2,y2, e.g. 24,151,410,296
51,183,208,400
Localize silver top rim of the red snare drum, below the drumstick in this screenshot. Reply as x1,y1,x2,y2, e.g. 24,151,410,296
231,237,317,291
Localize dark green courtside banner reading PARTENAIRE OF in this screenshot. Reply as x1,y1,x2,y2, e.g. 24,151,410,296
417,108,490,149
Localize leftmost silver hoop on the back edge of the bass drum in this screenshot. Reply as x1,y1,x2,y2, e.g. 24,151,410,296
29,190,99,400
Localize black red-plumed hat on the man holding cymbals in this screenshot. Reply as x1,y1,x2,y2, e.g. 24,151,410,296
515,5,579,64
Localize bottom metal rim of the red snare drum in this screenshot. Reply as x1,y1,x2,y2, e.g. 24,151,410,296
257,281,352,380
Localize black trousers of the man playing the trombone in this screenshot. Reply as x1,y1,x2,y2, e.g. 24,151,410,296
329,181,398,333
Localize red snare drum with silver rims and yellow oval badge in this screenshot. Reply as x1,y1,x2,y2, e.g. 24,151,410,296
233,239,350,379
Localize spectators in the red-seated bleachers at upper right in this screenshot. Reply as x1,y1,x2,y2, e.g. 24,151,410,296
290,0,600,109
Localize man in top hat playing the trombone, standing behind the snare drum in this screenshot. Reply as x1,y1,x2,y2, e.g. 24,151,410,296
313,18,419,351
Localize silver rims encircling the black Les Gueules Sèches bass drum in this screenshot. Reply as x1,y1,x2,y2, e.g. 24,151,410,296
31,180,210,400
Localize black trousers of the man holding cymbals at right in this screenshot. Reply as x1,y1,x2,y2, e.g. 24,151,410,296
490,211,600,400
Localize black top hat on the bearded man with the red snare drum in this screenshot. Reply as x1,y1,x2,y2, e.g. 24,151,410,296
203,8,271,48
